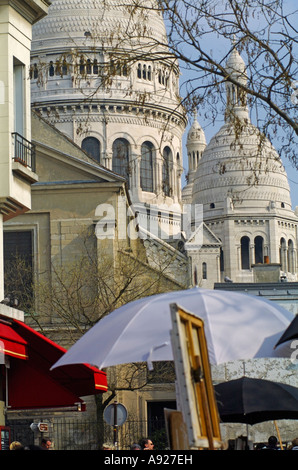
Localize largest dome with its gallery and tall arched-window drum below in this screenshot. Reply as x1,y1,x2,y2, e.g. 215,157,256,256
31,0,186,204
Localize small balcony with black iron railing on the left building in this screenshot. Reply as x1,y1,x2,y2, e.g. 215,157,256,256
12,132,38,183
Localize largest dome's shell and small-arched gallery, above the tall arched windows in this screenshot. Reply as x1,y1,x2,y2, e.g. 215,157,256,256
31,0,184,113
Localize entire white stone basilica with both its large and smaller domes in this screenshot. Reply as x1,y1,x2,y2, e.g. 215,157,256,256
25,0,298,294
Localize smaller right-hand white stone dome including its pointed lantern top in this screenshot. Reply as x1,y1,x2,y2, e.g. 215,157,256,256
193,48,291,218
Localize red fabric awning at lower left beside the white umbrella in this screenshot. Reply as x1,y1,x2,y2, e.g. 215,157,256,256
0,319,107,409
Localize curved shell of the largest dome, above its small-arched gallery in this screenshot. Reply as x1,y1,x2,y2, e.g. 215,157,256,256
32,0,167,55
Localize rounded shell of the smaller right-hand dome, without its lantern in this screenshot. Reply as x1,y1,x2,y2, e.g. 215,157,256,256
193,123,291,217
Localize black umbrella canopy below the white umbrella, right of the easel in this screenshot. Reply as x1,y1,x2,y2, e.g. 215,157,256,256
214,377,298,424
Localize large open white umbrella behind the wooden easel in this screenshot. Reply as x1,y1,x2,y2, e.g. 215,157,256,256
52,287,293,369
